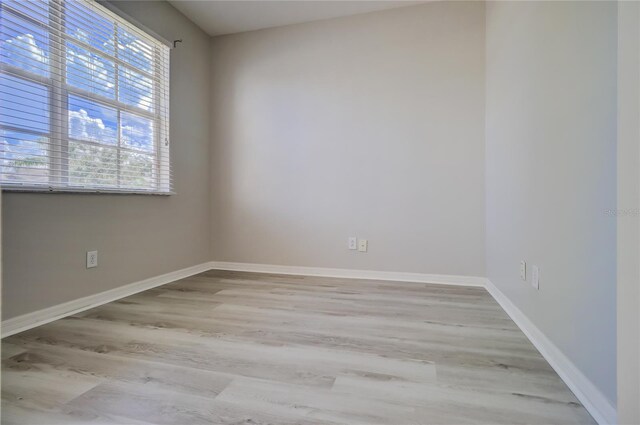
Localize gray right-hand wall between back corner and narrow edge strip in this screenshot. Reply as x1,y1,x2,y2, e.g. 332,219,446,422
486,2,617,405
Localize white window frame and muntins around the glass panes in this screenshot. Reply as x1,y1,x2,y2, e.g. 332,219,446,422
0,0,175,195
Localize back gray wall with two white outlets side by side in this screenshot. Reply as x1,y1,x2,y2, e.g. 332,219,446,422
211,2,485,276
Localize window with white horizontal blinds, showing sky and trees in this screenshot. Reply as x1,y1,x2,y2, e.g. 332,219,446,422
0,0,172,193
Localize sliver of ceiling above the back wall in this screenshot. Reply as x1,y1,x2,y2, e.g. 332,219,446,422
169,0,424,35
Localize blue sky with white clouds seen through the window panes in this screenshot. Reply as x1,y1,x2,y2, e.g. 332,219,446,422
0,0,154,174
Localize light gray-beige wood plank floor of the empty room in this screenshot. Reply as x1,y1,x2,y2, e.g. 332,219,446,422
2,271,594,425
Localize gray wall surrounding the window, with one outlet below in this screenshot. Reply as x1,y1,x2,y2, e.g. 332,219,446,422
2,2,211,319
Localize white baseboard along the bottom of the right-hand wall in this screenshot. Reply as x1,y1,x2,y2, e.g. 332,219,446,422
486,279,617,425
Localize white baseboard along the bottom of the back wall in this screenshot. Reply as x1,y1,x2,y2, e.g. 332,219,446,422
210,261,486,287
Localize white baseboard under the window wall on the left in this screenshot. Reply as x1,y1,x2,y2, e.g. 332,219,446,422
0,262,211,338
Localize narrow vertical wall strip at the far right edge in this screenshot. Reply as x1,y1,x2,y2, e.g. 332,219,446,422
618,2,640,424
